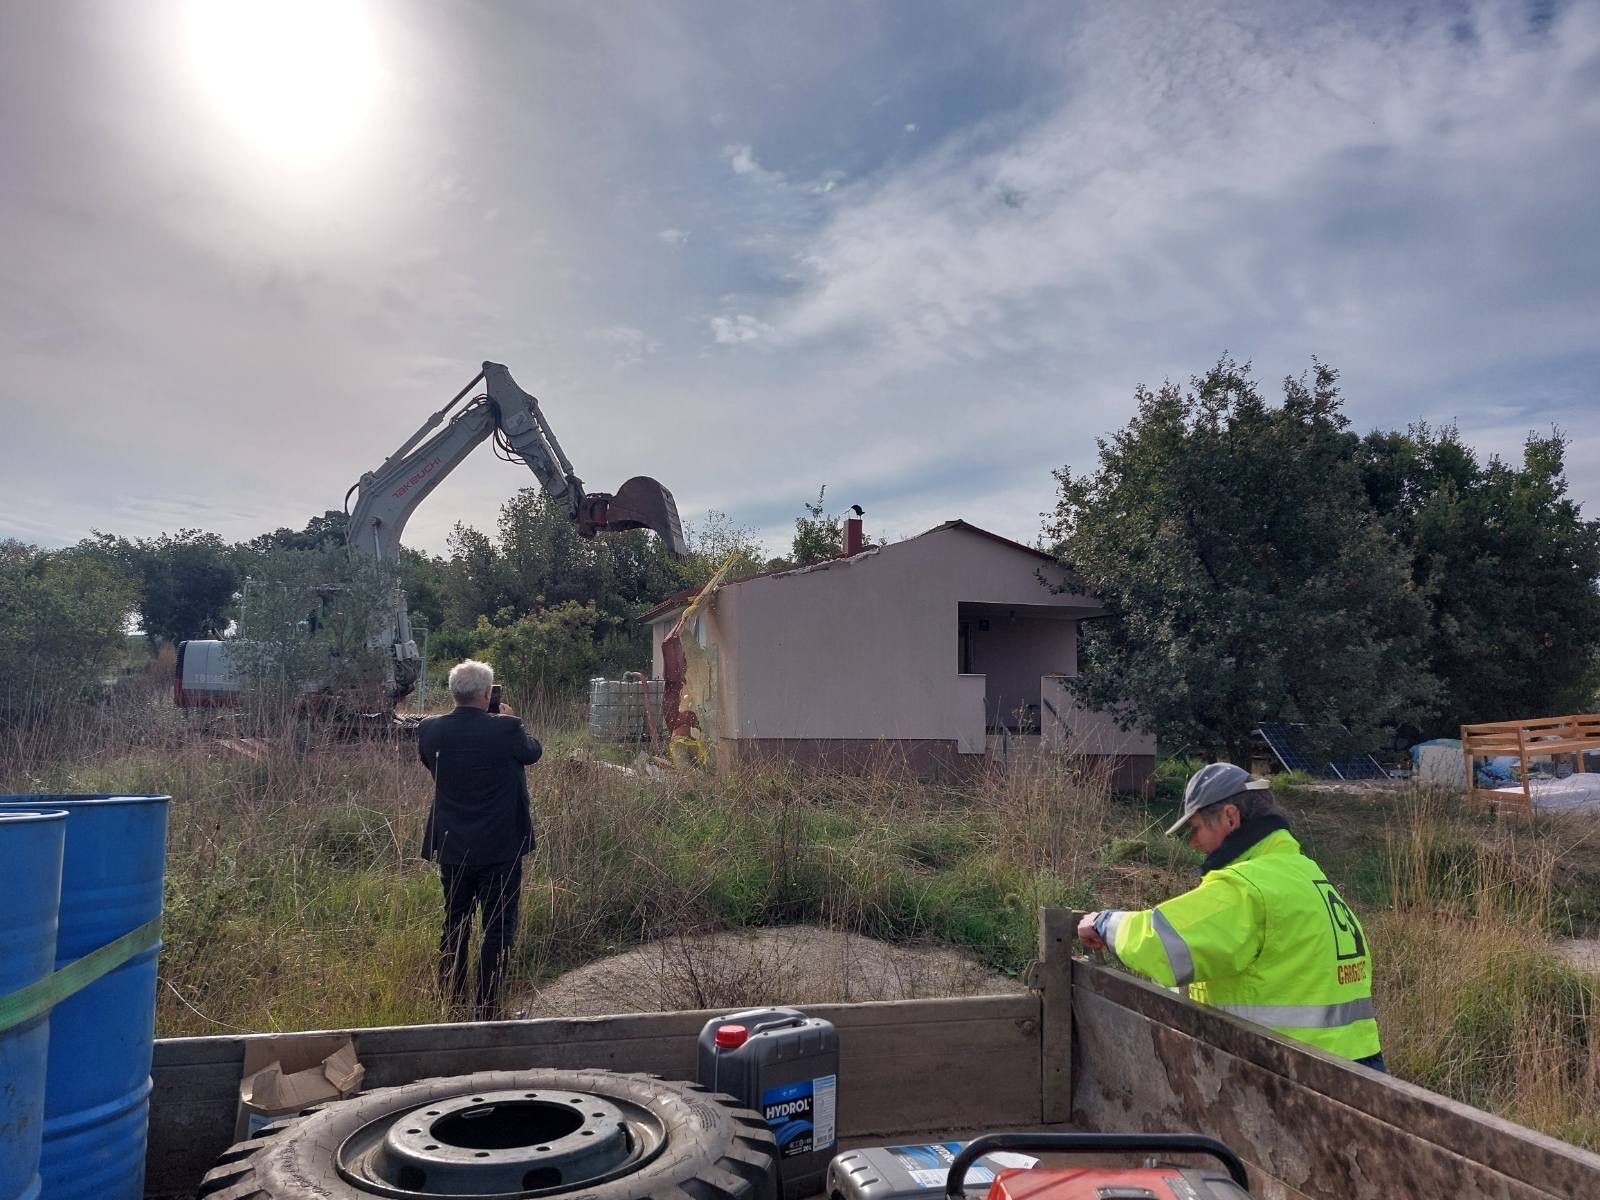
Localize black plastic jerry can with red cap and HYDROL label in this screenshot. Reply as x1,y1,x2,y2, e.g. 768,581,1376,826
698,1008,838,1200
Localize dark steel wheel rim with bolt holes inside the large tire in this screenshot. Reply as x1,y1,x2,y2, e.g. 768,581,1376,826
334,1091,666,1200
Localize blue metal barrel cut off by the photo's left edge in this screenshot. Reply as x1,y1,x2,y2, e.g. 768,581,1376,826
0,810,67,1200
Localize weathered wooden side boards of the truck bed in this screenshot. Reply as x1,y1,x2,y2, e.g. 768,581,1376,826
146,909,1600,1200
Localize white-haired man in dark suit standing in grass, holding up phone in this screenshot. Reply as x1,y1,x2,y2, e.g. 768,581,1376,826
416,659,541,1021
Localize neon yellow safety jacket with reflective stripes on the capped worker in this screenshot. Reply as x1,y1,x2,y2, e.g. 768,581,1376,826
1102,829,1381,1059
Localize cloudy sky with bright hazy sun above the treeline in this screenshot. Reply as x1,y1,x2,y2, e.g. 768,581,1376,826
0,0,1600,552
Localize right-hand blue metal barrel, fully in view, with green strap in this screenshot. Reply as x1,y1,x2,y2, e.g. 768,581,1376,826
0,795,168,1200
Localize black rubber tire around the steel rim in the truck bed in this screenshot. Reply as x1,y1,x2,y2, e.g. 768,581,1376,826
198,1070,778,1200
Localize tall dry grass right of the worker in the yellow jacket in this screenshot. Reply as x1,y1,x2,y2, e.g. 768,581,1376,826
1366,792,1600,1146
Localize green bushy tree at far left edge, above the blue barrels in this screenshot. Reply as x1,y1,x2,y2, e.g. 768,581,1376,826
0,541,138,723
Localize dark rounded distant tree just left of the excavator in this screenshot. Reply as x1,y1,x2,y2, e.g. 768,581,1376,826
90,530,238,654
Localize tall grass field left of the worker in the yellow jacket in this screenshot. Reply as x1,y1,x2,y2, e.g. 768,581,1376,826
0,675,1109,1035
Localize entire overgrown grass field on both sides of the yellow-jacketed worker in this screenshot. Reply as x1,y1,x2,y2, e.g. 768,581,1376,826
0,674,1600,1146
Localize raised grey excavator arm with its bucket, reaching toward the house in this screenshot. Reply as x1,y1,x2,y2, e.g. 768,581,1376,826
346,363,688,562
